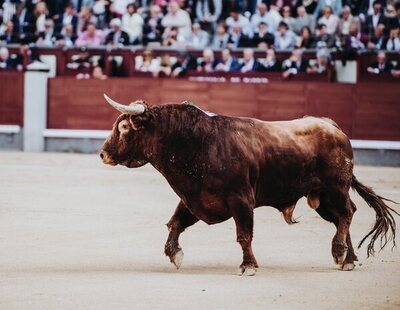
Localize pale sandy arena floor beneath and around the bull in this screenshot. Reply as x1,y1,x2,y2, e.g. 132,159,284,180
0,152,400,310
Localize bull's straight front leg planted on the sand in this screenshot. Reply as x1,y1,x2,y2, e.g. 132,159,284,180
230,199,258,276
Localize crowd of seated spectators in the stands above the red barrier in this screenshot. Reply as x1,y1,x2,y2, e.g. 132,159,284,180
0,0,400,77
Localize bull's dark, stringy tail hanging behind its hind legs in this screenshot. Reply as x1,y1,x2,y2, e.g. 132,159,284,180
351,175,400,257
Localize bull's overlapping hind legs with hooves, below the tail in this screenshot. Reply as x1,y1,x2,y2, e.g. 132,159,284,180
316,192,357,271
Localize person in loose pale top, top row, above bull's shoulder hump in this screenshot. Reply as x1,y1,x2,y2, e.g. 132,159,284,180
161,1,192,38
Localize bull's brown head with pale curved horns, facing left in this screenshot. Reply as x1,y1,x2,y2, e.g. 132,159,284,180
100,95,152,168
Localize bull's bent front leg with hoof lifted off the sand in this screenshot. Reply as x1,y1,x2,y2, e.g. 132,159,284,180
164,201,199,269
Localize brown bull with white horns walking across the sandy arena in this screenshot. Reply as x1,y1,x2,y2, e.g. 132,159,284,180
100,96,398,275
